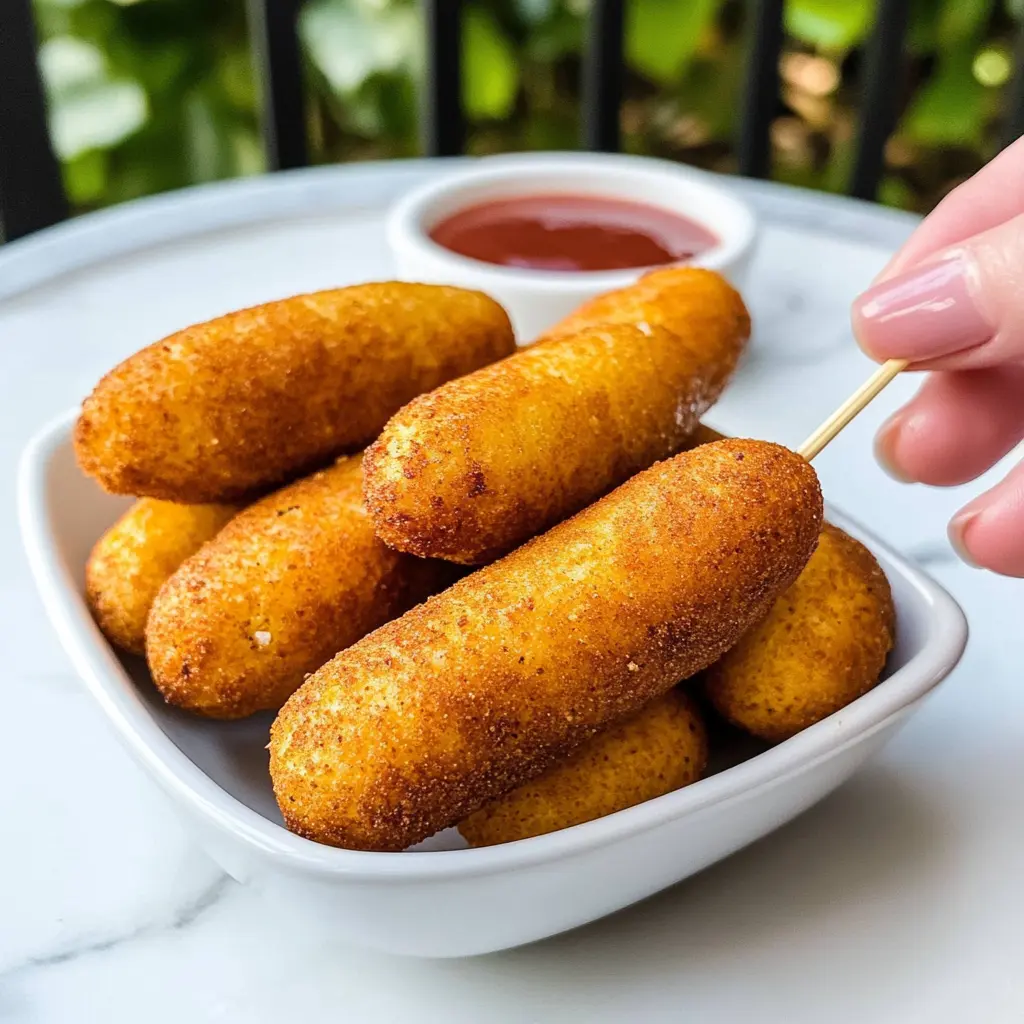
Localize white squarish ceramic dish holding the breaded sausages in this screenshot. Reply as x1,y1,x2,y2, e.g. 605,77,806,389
18,409,967,956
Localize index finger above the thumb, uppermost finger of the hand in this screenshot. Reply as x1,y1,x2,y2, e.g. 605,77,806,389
876,138,1024,281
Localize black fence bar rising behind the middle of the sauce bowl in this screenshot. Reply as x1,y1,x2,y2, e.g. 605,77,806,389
583,0,626,153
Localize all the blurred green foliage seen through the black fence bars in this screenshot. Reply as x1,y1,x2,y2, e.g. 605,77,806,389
29,0,1024,214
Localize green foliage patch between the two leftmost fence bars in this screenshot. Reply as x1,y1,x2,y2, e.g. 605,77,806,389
36,0,263,207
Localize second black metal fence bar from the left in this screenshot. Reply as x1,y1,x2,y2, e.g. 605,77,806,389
249,0,309,171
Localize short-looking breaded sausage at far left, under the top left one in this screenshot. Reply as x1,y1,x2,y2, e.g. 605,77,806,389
85,498,239,654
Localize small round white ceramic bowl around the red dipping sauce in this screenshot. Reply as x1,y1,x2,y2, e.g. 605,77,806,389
387,153,757,342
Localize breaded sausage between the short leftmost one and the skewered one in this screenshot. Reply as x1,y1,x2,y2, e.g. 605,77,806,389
145,456,452,718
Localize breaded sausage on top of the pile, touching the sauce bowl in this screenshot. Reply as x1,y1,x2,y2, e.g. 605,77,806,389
366,269,750,564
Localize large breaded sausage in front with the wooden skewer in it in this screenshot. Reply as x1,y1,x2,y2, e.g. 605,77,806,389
270,440,821,850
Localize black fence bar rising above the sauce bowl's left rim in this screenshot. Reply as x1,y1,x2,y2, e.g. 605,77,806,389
422,0,466,157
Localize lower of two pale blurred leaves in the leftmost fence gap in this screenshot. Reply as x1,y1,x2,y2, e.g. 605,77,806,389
50,82,148,160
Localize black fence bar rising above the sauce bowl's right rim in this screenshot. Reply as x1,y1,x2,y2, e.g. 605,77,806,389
736,0,782,178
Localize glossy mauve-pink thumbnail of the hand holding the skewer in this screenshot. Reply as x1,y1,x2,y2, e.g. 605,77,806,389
853,253,992,361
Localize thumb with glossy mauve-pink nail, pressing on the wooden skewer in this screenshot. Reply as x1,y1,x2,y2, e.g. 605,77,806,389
853,215,1024,370
